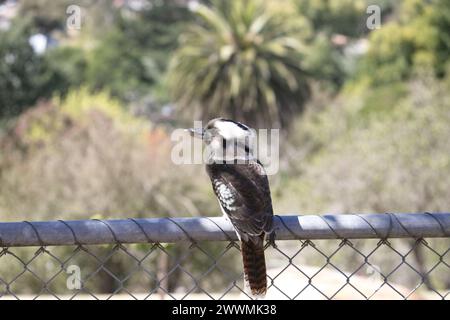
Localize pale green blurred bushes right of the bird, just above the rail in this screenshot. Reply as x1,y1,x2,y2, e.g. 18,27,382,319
275,75,450,213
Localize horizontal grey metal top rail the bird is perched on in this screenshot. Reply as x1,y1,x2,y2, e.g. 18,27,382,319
0,213,450,247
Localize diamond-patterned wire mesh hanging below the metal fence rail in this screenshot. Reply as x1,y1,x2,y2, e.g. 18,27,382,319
0,216,450,300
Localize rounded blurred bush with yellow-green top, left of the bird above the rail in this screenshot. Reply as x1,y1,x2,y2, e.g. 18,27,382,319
0,89,216,220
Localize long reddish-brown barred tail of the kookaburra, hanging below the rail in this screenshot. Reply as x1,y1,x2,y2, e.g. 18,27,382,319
241,239,267,297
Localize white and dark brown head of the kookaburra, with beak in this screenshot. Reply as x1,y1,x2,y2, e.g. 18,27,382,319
189,118,255,161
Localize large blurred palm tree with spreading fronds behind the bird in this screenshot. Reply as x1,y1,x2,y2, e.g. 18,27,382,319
168,0,309,127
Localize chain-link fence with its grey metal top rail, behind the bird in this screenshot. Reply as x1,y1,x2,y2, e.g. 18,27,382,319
0,213,450,300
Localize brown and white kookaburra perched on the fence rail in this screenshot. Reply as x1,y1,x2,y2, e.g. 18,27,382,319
189,118,273,297
